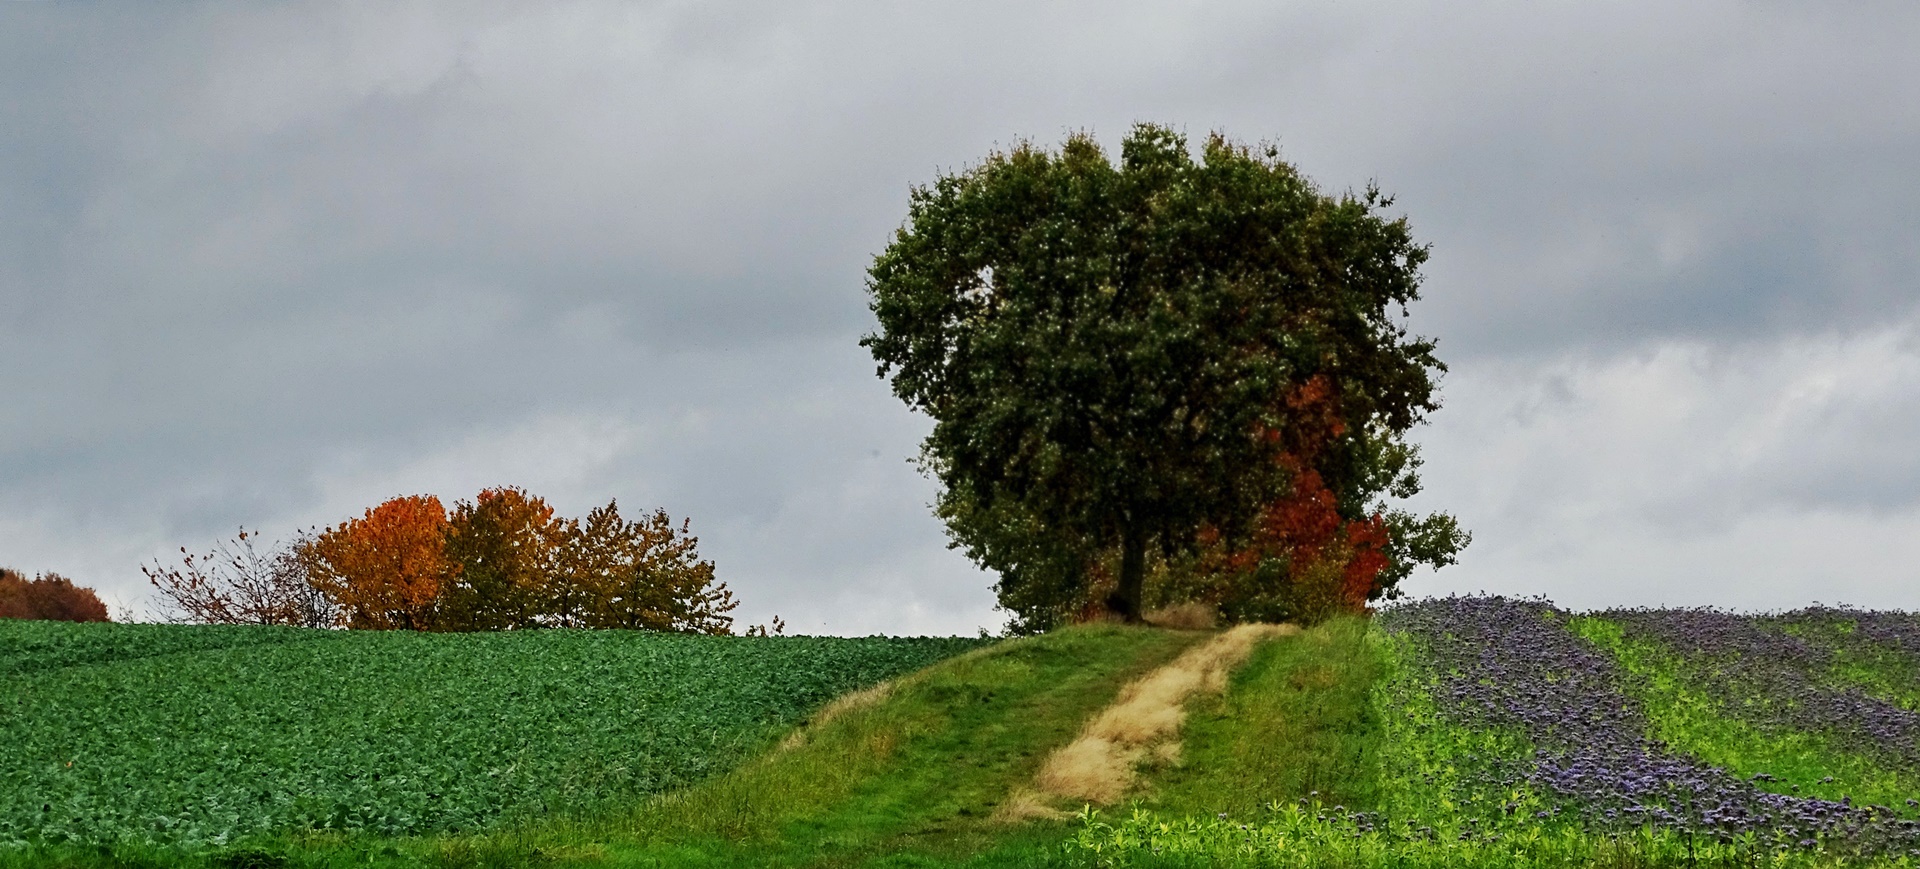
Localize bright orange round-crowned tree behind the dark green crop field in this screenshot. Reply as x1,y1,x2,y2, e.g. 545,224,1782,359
309,495,457,631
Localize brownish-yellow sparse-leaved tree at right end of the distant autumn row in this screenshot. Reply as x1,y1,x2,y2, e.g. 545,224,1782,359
551,501,739,633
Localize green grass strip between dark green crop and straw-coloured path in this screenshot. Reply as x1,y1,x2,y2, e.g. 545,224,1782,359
560,625,1196,865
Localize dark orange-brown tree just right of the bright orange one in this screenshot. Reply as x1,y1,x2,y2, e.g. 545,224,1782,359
440,487,568,631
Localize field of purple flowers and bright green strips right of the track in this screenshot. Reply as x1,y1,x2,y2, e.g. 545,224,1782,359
1068,597,1920,867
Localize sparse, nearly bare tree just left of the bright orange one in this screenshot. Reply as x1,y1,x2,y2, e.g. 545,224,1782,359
140,528,336,627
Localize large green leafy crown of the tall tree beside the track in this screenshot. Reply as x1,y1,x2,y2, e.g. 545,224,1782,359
860,125,1463,620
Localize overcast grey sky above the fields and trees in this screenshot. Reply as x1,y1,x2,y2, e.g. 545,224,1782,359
0,0,1920,635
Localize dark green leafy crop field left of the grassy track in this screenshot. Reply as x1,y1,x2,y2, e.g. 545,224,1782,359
0,620,983,852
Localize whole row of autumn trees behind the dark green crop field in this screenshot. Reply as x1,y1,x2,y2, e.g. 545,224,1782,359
142,487,737,633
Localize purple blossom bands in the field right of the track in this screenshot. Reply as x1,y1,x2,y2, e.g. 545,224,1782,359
1379,597,1920,856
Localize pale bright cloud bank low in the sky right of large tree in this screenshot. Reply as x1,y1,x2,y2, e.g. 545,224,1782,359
1415,318,1920,608
